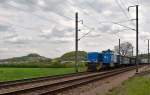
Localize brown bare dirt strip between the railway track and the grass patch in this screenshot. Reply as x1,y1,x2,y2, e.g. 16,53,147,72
59,66,148,95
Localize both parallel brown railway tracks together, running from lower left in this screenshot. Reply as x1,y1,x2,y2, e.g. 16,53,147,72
0,66,139,95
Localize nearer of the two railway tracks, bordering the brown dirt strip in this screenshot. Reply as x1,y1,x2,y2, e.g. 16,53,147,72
0,66,135,95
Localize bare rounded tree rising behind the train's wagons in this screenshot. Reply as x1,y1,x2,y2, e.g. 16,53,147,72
114,42,133,56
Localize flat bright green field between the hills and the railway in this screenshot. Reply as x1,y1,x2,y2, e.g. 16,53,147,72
0,68,85,81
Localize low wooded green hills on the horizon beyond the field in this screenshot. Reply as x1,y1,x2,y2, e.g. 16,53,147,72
0,51,87,64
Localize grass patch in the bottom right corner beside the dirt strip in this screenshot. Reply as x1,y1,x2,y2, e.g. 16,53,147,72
108,76,150,95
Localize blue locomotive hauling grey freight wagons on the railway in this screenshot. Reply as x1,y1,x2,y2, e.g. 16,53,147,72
87,49,136,71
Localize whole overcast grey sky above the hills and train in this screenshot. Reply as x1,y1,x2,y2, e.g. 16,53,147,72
0,0,150,59
